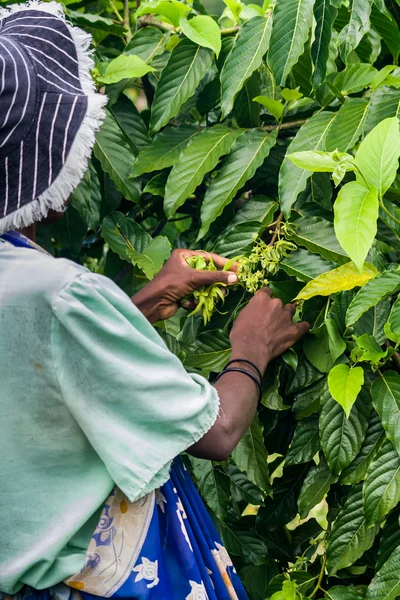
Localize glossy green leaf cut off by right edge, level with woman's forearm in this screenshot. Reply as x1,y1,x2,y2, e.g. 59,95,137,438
371,371,400,454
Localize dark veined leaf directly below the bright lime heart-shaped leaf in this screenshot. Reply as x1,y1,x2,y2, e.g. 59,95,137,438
319,382,371,475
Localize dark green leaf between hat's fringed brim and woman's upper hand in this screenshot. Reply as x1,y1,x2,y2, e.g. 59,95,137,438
102,212,151,262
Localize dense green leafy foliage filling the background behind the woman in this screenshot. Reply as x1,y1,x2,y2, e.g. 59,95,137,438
18,0,400,600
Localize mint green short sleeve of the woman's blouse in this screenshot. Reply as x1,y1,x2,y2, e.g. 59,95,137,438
52,273,219,501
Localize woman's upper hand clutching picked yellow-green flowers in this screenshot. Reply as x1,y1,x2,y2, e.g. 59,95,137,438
132,249,238,323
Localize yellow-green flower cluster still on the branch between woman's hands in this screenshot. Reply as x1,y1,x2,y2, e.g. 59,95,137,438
237,238,297,294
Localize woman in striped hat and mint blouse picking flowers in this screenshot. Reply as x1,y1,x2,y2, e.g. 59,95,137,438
0,2,308,600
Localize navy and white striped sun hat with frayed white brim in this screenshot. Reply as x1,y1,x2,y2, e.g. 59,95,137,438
0,0,107,234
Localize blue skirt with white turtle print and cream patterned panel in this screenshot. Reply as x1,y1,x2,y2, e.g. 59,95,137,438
9,458,248,600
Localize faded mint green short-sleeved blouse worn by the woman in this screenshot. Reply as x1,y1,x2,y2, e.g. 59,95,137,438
0,240,219,594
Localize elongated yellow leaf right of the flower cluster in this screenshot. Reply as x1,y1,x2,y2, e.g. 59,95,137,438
295,262,379,300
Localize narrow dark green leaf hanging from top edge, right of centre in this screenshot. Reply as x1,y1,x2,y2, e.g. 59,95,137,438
311,0,337,86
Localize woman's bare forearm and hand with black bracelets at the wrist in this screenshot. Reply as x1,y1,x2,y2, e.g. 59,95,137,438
189,288,309,460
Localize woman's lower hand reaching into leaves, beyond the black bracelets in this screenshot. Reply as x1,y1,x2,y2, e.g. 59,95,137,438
230,288,310,372
